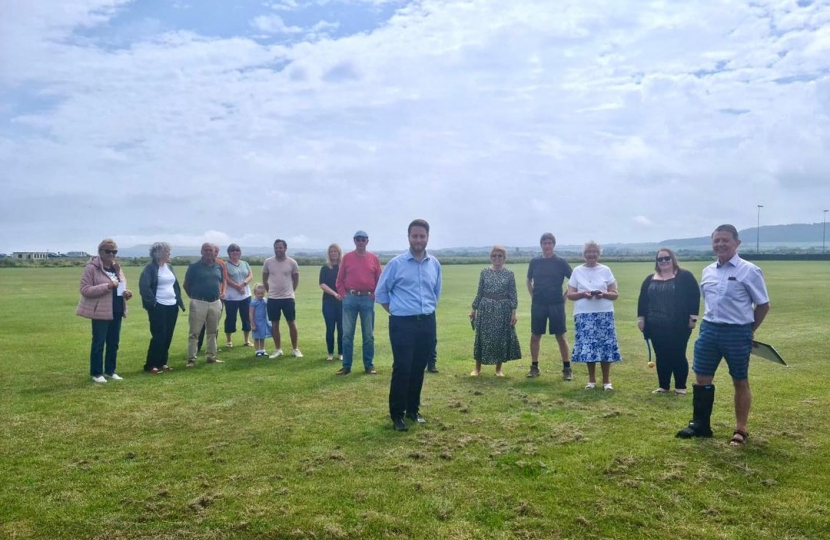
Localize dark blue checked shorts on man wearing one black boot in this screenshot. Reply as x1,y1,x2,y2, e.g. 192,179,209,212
692,321,752,381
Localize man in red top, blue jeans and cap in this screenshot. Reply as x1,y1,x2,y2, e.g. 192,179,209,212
337,231,380,375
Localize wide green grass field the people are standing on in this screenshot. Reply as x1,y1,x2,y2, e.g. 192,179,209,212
0,262,830,540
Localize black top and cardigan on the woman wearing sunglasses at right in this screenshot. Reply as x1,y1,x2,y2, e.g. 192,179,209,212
637,269,700,337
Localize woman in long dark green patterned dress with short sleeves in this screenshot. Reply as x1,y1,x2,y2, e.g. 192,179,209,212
470,246,522,377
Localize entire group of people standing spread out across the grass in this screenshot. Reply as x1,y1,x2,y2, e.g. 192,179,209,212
77,219,769,445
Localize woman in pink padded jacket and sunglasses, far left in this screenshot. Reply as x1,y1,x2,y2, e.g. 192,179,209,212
75,238,133,383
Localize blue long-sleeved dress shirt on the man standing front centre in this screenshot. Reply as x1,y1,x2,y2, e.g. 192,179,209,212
375,251,441,317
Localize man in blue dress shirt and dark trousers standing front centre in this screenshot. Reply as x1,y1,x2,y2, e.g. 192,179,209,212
375,219,441,431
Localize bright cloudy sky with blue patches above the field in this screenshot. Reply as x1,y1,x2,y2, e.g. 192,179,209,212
0,0,830,253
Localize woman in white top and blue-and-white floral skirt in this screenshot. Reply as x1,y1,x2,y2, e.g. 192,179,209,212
567,240,622,390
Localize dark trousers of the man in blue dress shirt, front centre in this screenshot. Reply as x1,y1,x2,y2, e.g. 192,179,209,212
389,313,436,420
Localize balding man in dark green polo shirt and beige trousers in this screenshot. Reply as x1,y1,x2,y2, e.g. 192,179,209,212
184,243,225,367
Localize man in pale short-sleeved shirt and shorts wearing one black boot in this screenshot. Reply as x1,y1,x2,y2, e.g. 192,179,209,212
677,225,769,446
